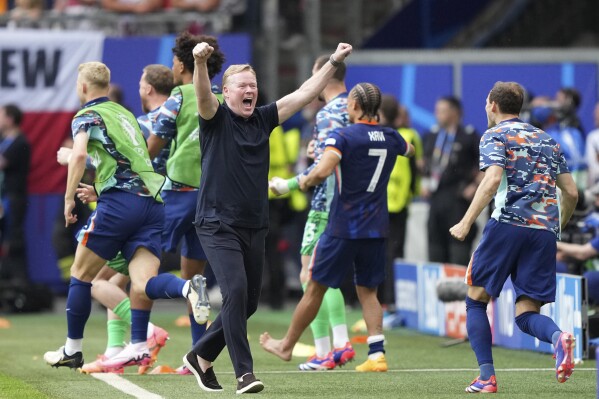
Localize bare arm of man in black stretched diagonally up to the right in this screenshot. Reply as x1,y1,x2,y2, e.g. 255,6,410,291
277,43,352,123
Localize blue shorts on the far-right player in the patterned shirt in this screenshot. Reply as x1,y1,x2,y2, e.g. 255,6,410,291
465,219,557,303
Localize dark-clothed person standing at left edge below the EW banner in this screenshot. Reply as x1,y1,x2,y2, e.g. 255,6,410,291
0,104,31,281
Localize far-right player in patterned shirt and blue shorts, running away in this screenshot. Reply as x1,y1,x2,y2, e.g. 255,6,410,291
449,82,578,393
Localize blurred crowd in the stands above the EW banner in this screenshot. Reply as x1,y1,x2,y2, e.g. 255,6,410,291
0,0,248,32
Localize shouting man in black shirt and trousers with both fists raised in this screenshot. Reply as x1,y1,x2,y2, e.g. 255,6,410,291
183,43,352,394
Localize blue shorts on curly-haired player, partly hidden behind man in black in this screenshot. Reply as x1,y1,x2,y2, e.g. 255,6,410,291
160,190,206,260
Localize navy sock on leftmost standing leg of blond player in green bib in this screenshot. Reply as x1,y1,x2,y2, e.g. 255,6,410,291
67,277,92,339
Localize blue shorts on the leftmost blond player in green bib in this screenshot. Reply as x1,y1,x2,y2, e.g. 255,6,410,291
77,189,164,262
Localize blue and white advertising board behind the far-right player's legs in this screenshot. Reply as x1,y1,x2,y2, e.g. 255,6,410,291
394,260,588,360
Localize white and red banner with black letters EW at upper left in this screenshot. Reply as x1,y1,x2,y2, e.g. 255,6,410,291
0,30,104,194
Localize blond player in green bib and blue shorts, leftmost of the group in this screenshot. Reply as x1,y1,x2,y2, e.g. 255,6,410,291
44,62,200,369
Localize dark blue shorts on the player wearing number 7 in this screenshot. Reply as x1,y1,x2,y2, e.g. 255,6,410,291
310,233,386,288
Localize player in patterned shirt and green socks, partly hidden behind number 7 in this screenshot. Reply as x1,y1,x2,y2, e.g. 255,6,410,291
270,56,356,371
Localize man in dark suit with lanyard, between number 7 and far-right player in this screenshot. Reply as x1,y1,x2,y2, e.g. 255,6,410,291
422,96,480,265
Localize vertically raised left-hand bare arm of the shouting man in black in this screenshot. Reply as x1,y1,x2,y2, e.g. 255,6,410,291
193,42,219,120
